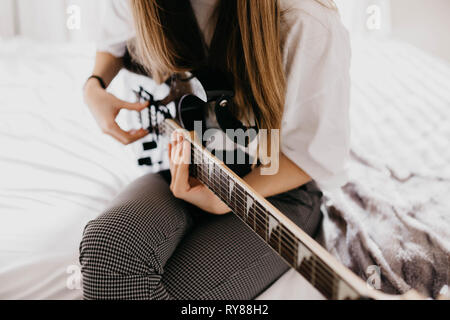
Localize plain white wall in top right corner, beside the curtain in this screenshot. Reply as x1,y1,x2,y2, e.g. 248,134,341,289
392,0,450,61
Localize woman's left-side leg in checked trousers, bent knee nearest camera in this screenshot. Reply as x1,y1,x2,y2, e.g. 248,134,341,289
80,174,192,299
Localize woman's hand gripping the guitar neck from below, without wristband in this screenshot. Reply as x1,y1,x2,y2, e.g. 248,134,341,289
169,132,231,215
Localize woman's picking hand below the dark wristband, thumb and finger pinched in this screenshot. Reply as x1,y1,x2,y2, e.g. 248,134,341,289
84,79,148,145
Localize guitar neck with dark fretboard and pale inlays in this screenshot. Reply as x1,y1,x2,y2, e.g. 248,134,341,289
163,120,380,299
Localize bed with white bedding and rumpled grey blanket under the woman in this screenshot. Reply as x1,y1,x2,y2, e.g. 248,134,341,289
0,39,450,299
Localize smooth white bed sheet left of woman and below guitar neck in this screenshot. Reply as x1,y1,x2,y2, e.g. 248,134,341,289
0,39,324,299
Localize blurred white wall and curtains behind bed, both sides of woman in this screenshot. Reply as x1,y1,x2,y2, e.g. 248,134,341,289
0,0,450,60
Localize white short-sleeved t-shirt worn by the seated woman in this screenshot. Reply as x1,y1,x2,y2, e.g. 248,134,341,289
97,0,351,190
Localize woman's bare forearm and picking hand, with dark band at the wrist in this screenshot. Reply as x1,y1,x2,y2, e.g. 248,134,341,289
84,52,148,145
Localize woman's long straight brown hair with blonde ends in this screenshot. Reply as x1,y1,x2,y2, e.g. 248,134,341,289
130,0,286,134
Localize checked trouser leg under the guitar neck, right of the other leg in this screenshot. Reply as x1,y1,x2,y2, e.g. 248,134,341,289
162,182,321,300
